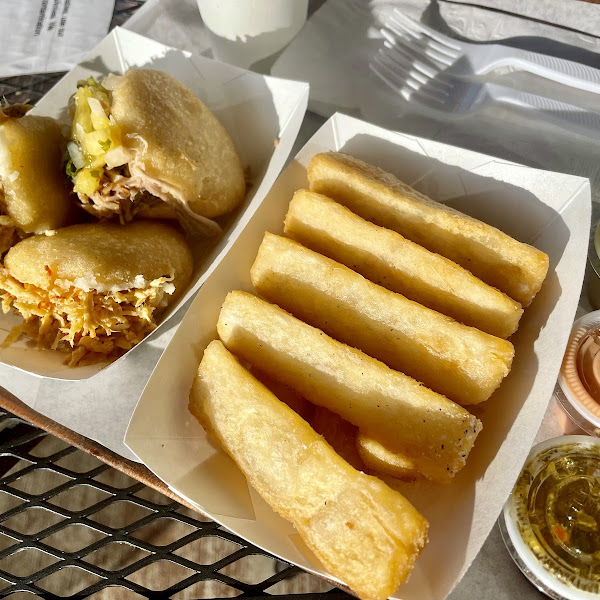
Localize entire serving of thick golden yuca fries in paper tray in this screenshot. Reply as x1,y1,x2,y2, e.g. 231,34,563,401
189,152,548,600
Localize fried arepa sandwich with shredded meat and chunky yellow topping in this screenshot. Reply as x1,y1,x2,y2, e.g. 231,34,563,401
67,70,246,228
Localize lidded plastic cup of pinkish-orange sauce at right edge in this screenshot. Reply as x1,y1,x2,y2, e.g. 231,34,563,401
556,310,600,436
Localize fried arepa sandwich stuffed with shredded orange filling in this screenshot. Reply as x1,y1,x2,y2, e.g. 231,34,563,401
0,221,192,366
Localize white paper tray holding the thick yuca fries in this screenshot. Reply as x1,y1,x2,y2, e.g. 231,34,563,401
125,114,591,600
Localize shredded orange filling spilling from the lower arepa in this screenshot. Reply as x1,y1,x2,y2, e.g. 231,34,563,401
0,267,175,366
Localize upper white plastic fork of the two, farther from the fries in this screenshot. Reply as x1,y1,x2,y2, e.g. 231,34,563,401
382,8,600,94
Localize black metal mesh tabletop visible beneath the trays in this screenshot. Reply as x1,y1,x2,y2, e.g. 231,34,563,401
0,0,350,600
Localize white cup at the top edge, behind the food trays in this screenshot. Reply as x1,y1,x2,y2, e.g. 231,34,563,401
198,0,308,69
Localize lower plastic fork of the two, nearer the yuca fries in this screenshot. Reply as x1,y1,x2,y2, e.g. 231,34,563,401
369,45,600,136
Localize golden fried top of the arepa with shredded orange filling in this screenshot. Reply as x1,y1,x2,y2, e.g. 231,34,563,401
4,221,193,293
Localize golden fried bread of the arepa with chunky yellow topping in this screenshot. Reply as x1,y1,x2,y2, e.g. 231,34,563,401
111,69,246,218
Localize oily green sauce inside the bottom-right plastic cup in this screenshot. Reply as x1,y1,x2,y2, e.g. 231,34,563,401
513,444,600,593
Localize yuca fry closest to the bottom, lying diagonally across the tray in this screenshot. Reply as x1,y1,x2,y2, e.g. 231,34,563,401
189,341,428,600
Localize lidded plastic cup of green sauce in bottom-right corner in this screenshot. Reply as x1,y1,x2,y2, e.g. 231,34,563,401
500,435,600,600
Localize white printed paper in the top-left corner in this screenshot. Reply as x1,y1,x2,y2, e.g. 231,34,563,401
0,0,115,77
